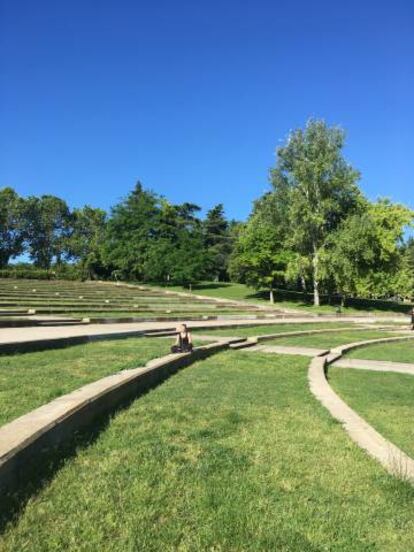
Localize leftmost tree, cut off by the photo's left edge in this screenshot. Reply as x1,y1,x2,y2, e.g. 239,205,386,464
0,188,24,268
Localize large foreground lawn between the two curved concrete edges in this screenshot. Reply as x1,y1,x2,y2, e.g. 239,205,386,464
0,352,414,552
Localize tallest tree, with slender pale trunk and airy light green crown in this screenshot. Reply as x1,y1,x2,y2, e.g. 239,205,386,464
271,120,361,306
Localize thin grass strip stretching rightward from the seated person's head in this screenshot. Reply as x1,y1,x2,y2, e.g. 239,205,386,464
192,322,360,337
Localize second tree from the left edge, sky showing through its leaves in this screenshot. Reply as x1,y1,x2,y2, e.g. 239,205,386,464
24,195,70,268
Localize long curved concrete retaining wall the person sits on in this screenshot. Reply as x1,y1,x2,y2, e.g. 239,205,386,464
0,339,232,494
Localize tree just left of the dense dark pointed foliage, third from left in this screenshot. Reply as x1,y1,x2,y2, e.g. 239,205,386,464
68,205,106,278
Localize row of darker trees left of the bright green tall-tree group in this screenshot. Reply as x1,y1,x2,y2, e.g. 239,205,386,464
0,183,236,283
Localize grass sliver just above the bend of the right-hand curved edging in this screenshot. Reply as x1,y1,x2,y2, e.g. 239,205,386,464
265,330,396,349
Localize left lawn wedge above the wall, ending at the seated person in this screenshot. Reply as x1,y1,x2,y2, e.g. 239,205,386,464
0,338,178,426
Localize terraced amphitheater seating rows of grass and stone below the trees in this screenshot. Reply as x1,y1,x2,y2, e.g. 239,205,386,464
0,279,272,319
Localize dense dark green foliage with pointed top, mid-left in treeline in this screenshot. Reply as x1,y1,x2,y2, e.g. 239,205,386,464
104,183,212,284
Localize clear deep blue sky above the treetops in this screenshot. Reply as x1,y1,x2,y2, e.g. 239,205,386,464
0,0,414,219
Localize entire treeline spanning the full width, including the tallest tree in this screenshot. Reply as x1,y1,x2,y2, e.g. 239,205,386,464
0,120,414,305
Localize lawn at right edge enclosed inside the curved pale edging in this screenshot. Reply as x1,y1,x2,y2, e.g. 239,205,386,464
329,366,414,458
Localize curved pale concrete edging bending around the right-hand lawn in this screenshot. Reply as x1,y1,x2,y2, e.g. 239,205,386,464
308,336,414,485
